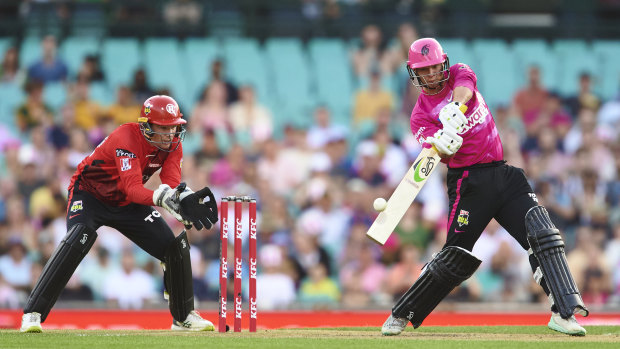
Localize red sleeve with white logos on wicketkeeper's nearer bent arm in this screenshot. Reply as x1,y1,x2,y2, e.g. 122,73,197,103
110,132,153,206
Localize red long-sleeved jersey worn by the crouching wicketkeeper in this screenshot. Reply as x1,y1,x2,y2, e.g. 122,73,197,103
69,123,183,206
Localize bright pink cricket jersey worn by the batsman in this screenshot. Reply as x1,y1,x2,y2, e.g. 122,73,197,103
411,63,504,168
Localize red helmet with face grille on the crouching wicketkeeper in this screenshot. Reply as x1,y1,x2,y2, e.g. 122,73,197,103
138,95,187,151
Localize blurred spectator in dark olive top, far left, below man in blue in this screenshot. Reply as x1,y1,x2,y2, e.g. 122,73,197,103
15,80,53,132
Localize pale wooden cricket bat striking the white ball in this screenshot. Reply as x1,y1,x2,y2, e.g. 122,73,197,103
366,147,441,245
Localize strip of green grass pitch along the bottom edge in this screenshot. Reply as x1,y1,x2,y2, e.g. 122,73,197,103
0,326,620,349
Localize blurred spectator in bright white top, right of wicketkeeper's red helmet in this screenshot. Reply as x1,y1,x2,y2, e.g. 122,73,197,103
230,85,273,145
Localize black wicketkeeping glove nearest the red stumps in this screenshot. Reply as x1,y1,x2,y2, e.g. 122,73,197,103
179,187,217,230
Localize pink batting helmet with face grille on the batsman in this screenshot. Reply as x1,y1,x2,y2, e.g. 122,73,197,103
407,38,450,92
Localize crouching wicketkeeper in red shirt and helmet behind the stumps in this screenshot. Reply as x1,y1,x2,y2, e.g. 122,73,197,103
20,96,217,332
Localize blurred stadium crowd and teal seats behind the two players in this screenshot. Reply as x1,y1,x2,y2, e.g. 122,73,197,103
0,0,620,320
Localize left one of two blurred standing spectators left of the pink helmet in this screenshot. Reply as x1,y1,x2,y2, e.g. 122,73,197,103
352,24,383,78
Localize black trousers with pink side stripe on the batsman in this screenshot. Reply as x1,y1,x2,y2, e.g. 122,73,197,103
445,161,538,251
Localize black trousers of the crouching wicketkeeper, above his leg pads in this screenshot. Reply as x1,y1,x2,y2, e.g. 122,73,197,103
67,185,174,261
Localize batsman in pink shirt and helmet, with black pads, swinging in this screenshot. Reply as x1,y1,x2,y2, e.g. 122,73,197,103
381,38,588,336
